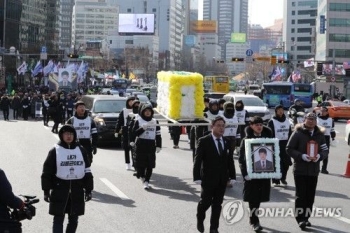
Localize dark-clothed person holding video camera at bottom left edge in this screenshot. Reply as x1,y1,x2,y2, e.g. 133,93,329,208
0,169,24,232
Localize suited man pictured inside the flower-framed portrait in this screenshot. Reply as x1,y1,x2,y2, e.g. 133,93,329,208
254,147,274,172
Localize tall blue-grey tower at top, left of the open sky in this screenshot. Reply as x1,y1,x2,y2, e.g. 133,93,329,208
203,0,248,59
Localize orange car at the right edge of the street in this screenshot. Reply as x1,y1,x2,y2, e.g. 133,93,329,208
314,100,350,121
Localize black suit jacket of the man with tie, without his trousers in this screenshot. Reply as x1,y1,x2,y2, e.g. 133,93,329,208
193,134,236,187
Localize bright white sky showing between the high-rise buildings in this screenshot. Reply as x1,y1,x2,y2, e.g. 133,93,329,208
198,0,284,28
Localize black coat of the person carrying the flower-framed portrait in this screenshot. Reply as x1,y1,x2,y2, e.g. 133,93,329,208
238,126,272,203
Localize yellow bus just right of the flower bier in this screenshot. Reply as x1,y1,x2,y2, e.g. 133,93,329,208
204,75,230,93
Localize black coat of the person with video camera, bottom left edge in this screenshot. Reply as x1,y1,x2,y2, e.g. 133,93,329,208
0,169,23,220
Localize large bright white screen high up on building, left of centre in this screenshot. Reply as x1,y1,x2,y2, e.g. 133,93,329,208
118,14,154,35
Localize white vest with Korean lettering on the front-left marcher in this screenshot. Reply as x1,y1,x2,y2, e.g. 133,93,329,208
55,144,85,180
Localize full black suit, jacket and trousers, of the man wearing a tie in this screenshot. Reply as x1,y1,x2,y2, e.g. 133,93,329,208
193,134,235,230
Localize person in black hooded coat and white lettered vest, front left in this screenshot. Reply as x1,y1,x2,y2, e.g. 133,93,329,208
41,125,94,233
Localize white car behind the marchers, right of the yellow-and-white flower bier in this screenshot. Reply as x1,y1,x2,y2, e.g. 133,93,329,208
223,93,271,123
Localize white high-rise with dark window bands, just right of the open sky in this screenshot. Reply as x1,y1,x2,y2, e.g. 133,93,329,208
282,0,318,65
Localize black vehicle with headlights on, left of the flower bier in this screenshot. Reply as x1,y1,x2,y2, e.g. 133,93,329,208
81,95,126,145
